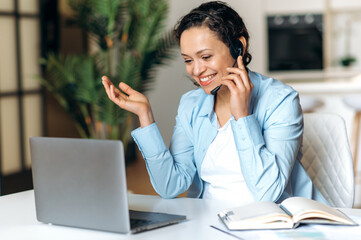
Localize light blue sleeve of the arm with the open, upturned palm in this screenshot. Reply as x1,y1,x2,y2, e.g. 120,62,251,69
132,113,196,198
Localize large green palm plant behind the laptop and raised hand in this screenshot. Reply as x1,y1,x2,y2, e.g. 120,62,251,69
39,0,176,147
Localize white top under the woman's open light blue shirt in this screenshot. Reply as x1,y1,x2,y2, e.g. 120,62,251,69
201,120,254,205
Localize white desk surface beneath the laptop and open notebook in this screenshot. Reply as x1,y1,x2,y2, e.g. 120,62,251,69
0,191,361,240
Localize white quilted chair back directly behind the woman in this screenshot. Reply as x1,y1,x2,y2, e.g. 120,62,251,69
301,113,355,208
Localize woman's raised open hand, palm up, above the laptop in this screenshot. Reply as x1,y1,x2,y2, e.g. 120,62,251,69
102,76,154,128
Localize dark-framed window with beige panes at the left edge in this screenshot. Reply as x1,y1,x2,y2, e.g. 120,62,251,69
0,0,57,193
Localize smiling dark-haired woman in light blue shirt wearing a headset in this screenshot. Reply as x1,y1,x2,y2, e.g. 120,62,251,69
103,1,327,204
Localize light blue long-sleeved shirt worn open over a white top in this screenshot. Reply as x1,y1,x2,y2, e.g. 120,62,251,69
132,70,328,204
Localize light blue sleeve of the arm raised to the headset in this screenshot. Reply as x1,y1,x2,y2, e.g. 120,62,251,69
231,87,303,202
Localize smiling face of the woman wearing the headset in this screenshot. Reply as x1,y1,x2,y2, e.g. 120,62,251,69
180,26,235,94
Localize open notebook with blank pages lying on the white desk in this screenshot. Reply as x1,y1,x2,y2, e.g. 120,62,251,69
218,197,358,230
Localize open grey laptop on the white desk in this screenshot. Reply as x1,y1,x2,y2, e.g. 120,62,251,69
30,137,186,233
